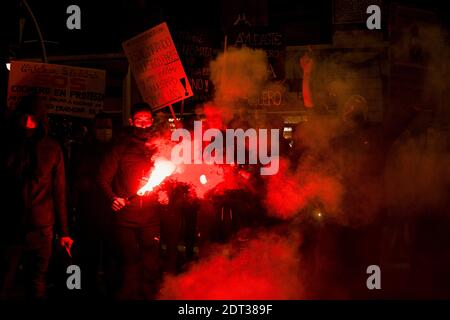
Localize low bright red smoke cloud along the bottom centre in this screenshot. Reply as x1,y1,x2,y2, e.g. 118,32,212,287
159,233,304,300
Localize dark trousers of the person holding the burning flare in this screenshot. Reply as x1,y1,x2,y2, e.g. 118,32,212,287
115,225,160,300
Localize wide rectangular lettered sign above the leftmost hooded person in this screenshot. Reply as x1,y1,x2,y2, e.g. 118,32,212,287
8,61,106,118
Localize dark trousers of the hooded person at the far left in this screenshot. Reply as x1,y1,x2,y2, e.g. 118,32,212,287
0,227,53,299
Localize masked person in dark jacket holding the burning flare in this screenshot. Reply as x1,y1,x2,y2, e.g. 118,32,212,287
98,103,160,299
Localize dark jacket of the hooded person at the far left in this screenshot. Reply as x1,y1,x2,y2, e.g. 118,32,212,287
0,136,68,242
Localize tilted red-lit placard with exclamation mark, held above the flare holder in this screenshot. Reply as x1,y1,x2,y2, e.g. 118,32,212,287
122,23,193,110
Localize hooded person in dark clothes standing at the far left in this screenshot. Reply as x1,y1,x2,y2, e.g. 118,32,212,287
0,95,73,298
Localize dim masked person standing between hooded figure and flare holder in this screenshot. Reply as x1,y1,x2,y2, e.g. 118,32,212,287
70,112,114,298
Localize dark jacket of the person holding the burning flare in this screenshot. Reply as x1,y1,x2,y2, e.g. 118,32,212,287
98,135,160,227
